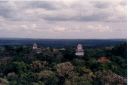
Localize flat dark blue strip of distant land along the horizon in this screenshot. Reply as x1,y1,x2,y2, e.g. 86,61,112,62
0,38,127,47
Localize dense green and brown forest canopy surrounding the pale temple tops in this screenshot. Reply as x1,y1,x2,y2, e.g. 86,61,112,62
0,44,127,85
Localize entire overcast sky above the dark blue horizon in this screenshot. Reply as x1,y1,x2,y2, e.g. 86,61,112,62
0,0,127,39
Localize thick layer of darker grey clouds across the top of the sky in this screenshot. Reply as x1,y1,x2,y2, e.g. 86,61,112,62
0,0,126,22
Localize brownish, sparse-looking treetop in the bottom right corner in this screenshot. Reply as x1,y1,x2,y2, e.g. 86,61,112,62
96,70,126,85
